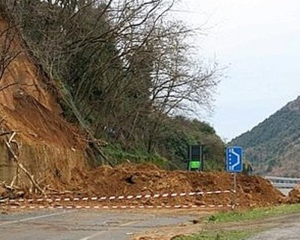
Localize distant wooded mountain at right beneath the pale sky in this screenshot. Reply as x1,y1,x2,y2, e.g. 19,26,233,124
229,96,300,177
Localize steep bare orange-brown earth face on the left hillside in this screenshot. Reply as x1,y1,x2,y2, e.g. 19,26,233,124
0,8,86,185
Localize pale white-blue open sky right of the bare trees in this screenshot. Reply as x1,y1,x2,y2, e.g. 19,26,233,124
174,0,300,141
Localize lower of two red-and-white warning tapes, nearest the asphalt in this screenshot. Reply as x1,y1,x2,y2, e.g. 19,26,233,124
7,204,232,209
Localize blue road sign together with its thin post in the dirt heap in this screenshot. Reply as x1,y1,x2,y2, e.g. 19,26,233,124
226,146,243,208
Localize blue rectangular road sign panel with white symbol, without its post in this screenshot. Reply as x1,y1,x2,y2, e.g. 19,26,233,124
226,146,243,172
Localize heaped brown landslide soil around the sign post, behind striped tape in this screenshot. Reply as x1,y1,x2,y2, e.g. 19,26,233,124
43,164,285,207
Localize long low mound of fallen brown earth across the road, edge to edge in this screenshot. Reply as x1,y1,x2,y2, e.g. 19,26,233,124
0,161,300,208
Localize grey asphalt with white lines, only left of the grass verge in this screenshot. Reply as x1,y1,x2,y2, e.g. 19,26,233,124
0,210,202,240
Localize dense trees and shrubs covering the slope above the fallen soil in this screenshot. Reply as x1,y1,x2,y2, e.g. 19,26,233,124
3,0,223,169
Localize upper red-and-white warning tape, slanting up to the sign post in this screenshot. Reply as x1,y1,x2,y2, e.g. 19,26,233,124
0,190,232,203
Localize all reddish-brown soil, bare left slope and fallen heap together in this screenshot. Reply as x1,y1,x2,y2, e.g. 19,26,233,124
0,7,294,212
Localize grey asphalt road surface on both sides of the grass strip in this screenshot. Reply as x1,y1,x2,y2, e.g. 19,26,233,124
0,209,300,240
